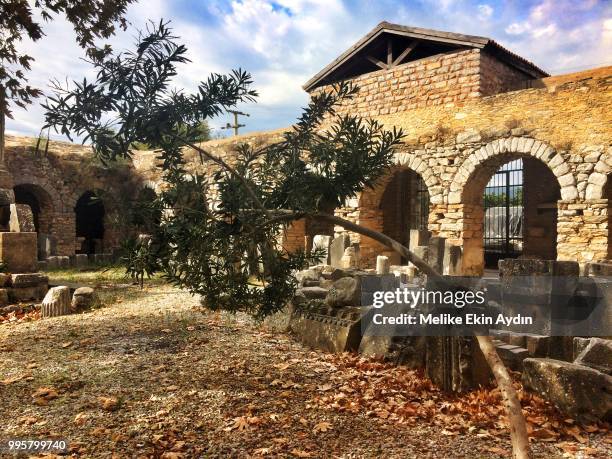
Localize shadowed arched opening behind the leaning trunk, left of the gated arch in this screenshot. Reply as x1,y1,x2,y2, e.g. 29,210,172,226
359,166,431,265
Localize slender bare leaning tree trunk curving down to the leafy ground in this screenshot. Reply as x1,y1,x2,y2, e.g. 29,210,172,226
313,213,531,459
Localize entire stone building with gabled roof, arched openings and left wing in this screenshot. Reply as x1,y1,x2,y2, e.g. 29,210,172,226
2,22,612,274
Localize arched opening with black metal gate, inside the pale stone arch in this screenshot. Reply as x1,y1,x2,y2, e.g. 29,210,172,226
462,153,561,275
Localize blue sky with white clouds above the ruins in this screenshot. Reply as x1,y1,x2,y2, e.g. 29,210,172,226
7,0,612,139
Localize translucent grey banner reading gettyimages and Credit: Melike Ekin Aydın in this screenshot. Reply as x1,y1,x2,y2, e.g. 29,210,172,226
361,276,612,336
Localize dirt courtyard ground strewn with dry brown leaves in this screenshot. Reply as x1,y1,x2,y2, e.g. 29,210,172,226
0,284,612,458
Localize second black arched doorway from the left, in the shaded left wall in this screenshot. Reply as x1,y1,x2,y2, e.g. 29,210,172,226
74,191,105,254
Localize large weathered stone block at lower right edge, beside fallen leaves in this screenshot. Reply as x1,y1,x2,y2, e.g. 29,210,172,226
522,358,612,422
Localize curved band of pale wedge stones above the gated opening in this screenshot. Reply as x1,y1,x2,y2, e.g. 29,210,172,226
447,137,578,204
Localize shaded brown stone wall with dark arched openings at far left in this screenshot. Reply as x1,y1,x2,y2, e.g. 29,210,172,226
6,136,143,258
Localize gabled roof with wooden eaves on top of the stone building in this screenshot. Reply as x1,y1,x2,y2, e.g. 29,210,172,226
303,21,549,91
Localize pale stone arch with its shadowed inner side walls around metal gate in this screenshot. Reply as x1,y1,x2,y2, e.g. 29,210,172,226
448,137,578,275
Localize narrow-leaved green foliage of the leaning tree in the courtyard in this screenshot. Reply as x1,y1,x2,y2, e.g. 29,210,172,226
45,22,403,318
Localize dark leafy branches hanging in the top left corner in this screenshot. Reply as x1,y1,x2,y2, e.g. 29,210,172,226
0,0,134,117
